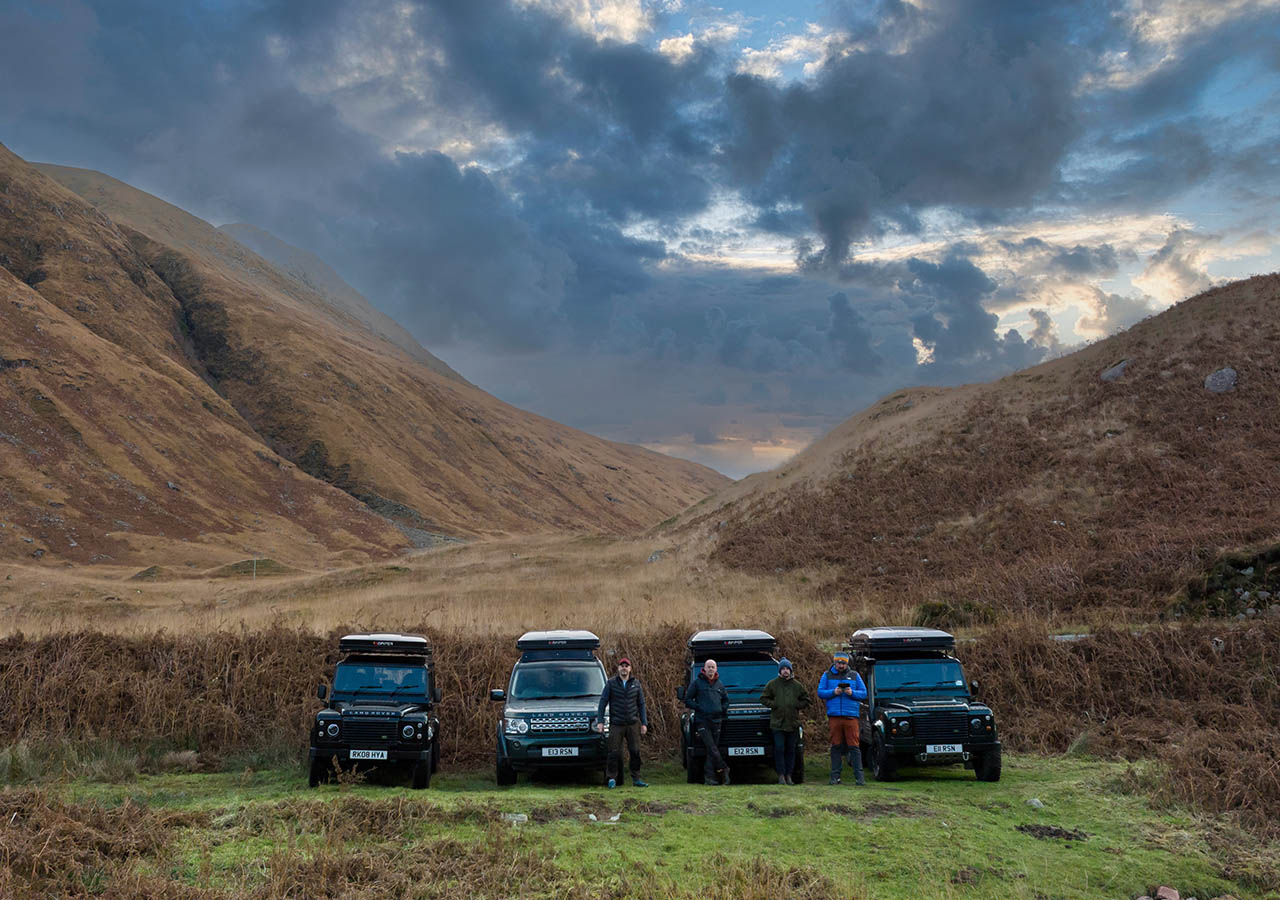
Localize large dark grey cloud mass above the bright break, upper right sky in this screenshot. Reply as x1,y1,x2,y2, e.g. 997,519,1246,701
724,0,1112,266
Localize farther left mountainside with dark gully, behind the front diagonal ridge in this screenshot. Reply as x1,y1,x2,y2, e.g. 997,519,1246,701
0,151,727,565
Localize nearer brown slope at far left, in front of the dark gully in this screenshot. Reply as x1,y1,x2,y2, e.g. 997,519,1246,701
0,147,407,566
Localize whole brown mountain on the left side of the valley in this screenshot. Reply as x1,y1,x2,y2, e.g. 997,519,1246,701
0,147,726,565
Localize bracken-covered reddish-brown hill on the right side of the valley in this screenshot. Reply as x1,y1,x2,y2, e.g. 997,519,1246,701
701,275,1280,625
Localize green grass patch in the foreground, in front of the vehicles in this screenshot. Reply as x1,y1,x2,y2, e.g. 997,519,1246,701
47,757,1276,900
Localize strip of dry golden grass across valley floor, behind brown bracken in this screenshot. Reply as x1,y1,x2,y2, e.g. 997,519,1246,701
0,536,875,635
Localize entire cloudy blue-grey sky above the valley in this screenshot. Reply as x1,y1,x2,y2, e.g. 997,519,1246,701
0,0,1280,478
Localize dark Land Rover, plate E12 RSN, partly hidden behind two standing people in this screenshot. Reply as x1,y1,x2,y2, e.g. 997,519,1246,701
676,630,804,785
